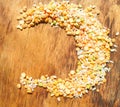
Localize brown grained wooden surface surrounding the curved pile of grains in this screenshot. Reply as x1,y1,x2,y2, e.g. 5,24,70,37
0,0,120,107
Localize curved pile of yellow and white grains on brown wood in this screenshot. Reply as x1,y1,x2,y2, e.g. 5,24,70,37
17,1,116,100
